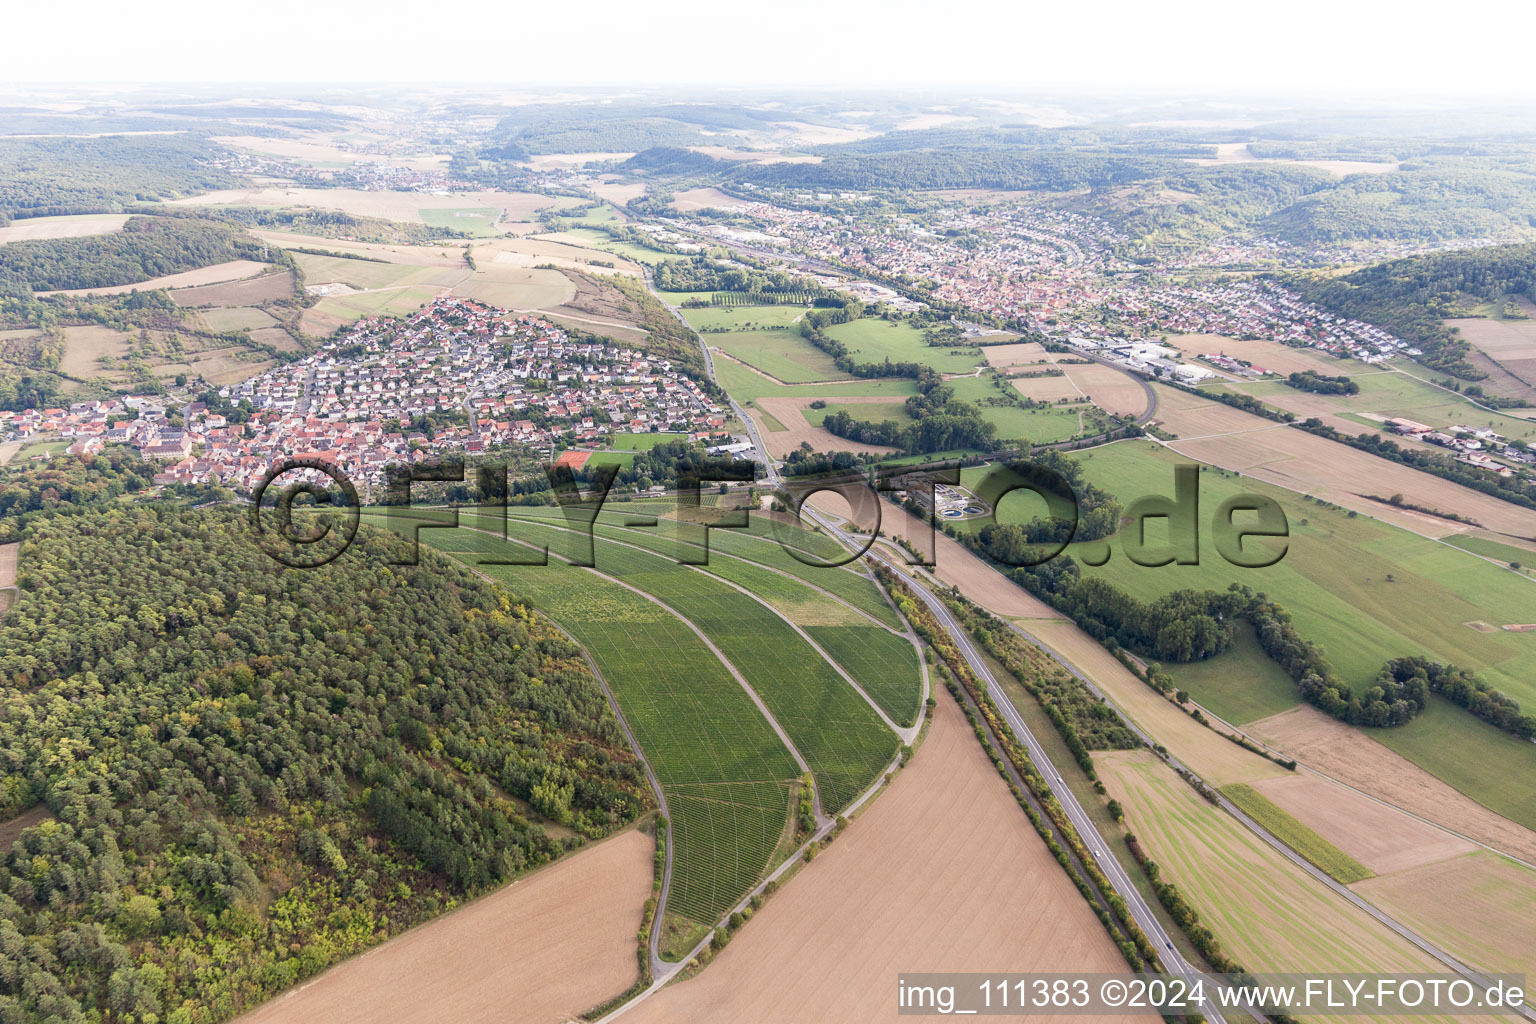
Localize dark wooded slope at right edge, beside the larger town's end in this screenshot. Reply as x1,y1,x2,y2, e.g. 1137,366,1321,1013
1286,244,1536,379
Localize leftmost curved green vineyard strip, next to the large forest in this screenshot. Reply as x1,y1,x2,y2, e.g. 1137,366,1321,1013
411,534,803,924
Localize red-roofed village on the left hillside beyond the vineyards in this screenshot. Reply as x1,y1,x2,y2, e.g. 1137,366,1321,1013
0,298,731,490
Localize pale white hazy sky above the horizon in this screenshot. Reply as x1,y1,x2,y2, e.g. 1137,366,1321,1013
12,0,1536,98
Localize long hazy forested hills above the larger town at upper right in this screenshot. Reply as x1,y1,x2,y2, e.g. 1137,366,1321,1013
724,143,1536,246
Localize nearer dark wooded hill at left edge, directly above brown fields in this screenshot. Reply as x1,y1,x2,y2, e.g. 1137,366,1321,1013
0,216,281,292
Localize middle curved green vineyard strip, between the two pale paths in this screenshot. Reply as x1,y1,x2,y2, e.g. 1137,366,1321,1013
454,520,897,814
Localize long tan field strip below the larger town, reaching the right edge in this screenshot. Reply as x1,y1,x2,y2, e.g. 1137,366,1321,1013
1154,385,1536,537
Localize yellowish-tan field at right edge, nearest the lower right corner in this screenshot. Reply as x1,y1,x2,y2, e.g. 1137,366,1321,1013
1350,851,1536,975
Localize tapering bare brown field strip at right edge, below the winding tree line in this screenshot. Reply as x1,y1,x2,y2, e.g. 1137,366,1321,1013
1244,705,1536,861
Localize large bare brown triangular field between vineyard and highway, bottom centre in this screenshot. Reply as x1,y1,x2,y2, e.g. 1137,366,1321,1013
622,688,1157,1024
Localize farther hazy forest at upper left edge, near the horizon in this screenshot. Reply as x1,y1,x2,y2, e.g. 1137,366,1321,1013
0,135,233,224
